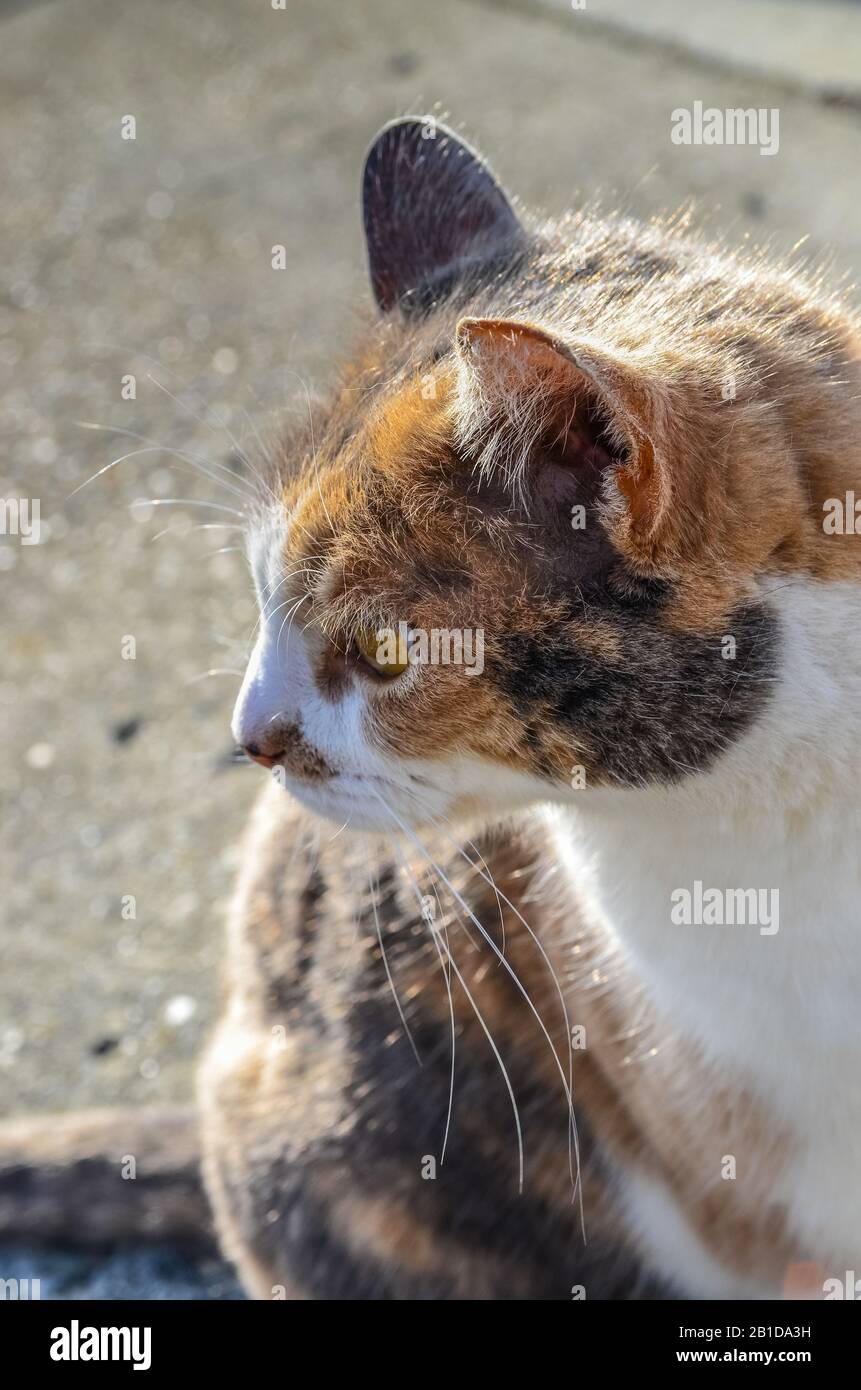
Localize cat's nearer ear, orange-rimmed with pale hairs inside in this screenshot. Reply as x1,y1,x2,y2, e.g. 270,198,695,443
455,318,670,542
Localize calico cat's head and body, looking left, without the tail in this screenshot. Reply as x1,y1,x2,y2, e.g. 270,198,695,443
200,120,861,1300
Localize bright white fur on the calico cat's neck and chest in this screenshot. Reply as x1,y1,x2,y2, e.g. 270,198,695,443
552,581,861,1294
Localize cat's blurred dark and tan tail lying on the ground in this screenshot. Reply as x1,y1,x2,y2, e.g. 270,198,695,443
0,1105,214,1248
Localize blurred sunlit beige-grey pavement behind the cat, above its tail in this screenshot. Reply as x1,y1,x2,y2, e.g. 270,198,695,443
0,0,861,1295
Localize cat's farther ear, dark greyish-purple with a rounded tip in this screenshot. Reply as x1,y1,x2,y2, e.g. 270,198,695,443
362,117,524,310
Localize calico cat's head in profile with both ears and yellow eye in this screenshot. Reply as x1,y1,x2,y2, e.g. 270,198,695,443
234,120,857,826
